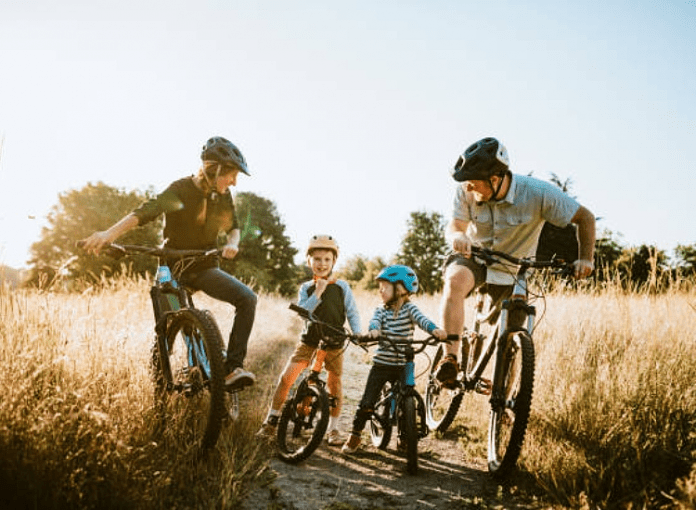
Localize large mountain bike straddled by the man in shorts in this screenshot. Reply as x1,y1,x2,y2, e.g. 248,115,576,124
425,246,573,477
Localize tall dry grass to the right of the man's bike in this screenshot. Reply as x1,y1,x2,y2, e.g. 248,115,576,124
523,288,696,508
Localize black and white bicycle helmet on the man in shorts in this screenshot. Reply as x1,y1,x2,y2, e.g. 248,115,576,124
452,137,510,182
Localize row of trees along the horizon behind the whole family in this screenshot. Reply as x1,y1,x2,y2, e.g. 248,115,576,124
28,182,696,296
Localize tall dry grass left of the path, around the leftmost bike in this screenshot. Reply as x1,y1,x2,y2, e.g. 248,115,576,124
0,279,298,509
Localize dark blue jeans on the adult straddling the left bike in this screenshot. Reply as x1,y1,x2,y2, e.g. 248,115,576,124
182,267,257,371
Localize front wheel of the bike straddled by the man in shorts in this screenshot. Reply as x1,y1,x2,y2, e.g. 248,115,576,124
488,331,534,478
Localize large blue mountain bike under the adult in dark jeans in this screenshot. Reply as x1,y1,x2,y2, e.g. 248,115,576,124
89,244,241,451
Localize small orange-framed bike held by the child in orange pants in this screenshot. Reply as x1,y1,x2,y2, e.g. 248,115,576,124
277,304,363,464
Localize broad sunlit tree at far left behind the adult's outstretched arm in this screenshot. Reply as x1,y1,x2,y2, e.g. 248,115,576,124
29,182,161,283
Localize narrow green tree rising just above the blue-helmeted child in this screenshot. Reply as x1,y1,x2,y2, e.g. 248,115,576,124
396,211,447,294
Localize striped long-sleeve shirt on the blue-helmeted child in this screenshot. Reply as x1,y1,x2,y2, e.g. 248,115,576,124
368,301,437,366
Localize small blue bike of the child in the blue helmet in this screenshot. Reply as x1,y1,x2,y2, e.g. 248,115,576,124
363,335,457,475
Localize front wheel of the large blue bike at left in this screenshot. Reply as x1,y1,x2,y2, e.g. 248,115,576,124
153,309,227,451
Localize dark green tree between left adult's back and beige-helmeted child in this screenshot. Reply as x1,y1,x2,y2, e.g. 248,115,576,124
222,192,298,296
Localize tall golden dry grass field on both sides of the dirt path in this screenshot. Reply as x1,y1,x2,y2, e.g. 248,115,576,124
0,279,696,509
